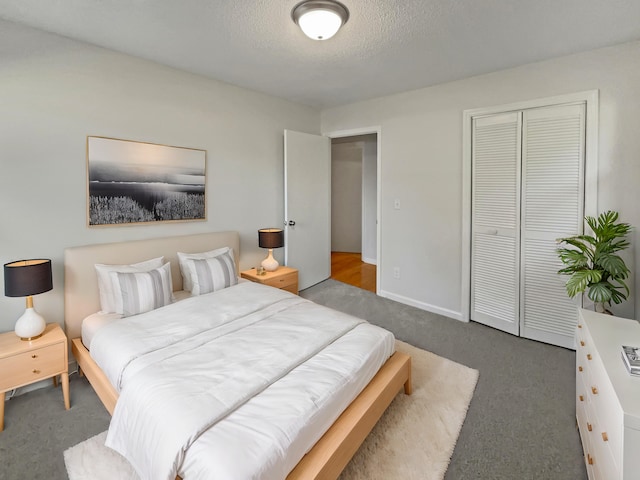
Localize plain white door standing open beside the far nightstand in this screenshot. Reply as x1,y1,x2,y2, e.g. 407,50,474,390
284,130,331,290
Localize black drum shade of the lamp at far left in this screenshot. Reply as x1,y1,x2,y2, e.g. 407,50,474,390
4,259,53,297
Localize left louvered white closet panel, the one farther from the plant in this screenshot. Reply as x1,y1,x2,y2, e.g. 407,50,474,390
471,113,521,335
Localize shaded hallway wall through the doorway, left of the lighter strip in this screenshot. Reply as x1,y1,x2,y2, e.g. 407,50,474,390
331,142,362,253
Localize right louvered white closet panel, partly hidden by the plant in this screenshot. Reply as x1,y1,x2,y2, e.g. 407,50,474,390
520,105,585,348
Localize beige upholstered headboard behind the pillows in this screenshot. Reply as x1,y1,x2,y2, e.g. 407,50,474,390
64,232,240,339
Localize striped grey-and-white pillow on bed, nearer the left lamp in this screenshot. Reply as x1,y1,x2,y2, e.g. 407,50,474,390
110,263,173,317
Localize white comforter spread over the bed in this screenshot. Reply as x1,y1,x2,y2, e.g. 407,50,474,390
91,283,393,480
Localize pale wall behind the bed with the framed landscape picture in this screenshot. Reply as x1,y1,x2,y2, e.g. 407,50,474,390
0,21,320,331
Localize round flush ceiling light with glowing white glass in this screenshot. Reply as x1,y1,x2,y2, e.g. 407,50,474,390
291,0,349,40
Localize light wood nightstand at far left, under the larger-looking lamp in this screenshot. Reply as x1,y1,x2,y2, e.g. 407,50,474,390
0,323,69,432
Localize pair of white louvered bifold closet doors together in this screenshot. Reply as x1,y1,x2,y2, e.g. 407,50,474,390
470,102,586,348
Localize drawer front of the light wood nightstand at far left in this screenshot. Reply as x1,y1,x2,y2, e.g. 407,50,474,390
0,342,67,391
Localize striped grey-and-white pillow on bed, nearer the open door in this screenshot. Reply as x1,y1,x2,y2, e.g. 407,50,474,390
186,251,238,295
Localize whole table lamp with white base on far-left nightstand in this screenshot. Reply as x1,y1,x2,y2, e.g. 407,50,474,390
4,259,53,340
